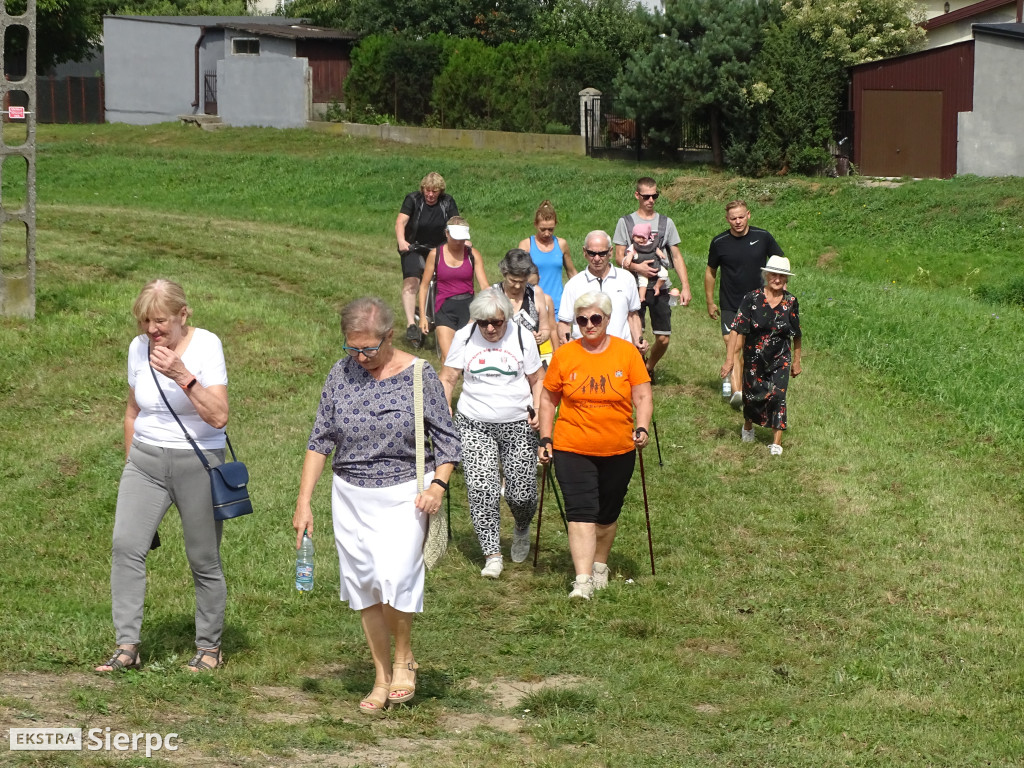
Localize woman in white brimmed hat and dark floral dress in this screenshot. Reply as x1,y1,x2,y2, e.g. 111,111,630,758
721,256,801,456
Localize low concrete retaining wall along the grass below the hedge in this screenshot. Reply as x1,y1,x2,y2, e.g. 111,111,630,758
308,123,587,155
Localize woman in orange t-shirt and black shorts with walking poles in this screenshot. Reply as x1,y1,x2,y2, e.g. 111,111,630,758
538,292,653,600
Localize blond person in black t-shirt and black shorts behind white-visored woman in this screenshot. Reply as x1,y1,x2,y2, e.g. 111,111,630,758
394,171,459,347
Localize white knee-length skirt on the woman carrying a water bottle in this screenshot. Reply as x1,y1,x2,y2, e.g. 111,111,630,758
331,473,432,613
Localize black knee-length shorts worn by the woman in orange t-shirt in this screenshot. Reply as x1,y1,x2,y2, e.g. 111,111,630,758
554,451,637,525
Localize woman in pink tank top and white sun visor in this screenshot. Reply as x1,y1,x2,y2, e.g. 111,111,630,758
419,216,490,362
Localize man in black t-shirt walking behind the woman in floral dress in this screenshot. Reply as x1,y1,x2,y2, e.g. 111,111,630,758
705,200,785,408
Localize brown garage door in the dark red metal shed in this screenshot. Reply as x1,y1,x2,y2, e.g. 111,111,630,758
859,90,942,177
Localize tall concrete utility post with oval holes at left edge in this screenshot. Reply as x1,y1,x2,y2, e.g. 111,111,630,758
0,0,37,317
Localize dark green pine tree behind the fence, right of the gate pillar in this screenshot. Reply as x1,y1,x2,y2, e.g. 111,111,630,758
616,0,773,166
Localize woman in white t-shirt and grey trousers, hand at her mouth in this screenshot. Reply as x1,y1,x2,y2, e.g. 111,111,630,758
96,280,228,672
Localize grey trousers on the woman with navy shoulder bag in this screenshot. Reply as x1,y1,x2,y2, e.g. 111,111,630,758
111,440,227,648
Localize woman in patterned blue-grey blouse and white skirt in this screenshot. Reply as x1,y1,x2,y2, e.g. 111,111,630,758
292,298,460,713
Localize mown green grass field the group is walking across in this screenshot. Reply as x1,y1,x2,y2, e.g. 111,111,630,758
0,126,1024,768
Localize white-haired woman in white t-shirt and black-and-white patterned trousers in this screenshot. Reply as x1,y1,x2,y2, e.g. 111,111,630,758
440,288,543,579
